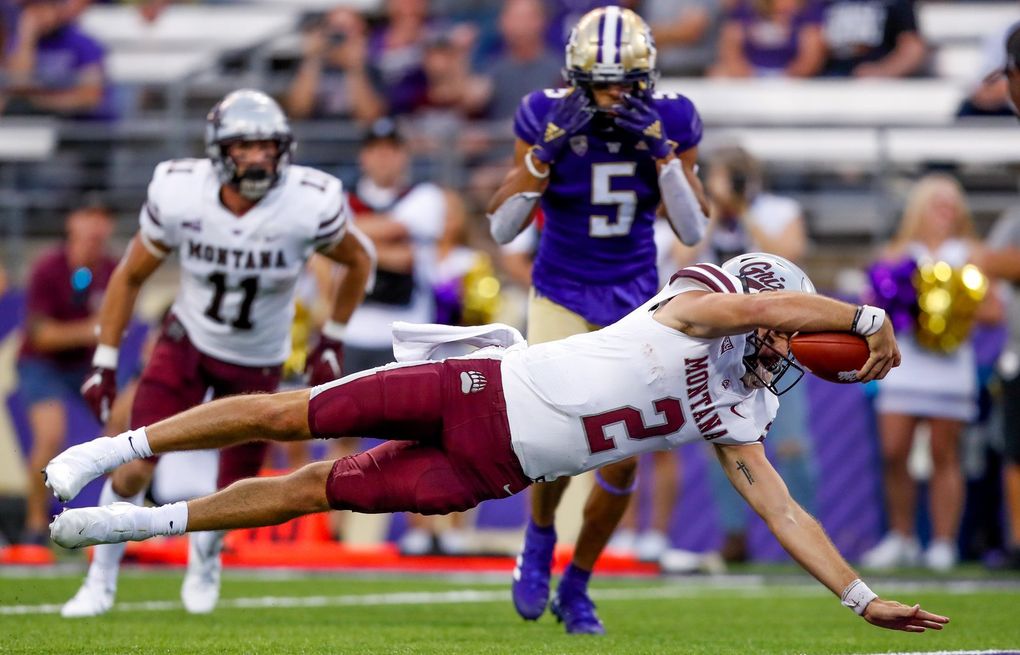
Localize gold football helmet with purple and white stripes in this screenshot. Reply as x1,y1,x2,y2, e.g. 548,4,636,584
563,6,659,89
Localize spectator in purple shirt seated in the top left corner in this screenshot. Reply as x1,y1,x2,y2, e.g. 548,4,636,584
4,0,116,120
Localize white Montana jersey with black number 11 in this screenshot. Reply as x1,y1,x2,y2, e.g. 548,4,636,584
139,159,350,366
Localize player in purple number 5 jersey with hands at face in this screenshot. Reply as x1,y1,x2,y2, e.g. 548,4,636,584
489,7,707,634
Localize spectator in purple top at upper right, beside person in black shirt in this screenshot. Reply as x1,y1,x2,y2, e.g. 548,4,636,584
709,0,825,78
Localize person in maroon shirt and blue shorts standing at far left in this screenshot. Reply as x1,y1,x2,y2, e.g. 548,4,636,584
17,207,117,544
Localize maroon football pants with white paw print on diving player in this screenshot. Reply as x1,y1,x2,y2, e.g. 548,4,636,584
308,359,531,514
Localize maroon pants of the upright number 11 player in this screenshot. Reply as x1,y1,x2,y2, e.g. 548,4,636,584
131,314,282,489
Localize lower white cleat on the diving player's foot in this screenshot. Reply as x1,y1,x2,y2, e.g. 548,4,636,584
50,503,152,548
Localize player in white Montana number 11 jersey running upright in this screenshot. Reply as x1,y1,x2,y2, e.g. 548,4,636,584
62,90,373,617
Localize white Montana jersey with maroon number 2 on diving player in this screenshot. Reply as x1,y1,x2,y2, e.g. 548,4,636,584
502,264,779,481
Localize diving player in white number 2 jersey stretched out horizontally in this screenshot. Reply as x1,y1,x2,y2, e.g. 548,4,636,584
46,253,949,633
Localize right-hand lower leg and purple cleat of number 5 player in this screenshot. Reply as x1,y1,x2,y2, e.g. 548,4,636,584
550,457,638,635
